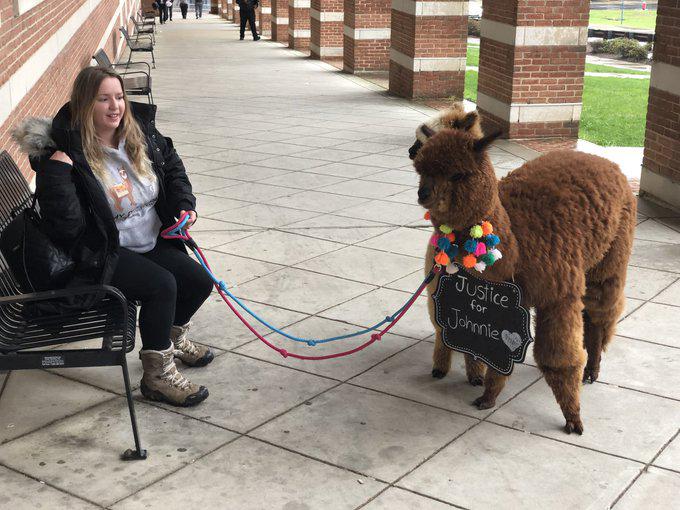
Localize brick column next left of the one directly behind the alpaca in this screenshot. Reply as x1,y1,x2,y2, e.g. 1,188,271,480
390,0,468,99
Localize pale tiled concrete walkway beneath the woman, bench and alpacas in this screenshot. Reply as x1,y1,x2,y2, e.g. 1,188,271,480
0,13,680,510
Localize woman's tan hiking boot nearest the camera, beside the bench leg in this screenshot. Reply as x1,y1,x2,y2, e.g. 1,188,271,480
139,346,208,407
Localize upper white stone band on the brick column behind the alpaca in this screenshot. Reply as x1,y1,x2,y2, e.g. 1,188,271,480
481,18,588,46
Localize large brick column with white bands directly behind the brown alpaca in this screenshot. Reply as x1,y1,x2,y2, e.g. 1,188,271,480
477,0,590,138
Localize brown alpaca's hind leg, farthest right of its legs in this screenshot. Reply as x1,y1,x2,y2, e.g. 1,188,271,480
583,210,635,382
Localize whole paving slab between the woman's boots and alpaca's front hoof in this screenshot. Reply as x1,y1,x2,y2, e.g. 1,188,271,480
251,385,477,481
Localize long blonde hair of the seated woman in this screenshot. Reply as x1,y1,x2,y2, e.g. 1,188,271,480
71,66,156,181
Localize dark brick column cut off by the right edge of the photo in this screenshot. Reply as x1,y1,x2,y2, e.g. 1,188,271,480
640,0,680,210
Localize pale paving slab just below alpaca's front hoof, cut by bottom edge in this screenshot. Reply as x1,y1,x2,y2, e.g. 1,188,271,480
398,423,643,510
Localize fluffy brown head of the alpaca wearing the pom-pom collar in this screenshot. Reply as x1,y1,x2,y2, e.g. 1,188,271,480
413,112,500,230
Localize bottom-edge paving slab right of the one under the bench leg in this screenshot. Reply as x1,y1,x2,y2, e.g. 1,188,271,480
113,438,385,510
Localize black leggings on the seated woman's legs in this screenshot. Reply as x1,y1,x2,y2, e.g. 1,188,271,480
111,238,212,351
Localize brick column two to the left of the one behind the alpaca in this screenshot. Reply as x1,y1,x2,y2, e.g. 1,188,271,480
343,0,392,73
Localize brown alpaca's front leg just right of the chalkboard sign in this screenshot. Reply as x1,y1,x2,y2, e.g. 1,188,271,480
534,298,586,434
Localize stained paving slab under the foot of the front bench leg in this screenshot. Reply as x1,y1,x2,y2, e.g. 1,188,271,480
0,397,236,506
